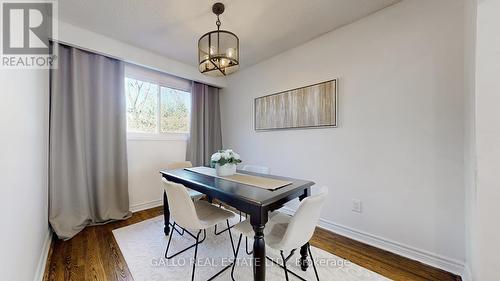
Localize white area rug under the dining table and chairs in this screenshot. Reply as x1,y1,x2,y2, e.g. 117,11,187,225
113,213,389,281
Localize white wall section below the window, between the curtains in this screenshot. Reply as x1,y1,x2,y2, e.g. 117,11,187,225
127,139,186,211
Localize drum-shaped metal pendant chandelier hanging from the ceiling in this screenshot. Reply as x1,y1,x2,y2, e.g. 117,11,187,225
198,3,240,76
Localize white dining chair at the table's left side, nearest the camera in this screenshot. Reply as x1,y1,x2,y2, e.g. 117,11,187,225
162,178,235,281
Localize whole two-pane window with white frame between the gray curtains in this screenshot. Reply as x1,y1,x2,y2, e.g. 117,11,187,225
125,63,191,138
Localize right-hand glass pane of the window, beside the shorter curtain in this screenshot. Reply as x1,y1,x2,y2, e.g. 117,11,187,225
160,87,191,133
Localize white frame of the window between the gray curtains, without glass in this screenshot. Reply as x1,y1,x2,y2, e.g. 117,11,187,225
123,66,193,141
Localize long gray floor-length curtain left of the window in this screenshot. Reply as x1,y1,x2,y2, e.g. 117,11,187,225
49,44,130,240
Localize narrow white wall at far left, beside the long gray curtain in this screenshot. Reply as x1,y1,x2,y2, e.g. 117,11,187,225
0,70,50,281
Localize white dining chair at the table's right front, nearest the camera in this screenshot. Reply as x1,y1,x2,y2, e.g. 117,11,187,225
231,187,328,281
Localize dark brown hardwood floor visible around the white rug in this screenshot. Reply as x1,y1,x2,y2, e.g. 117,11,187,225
44,207,461,281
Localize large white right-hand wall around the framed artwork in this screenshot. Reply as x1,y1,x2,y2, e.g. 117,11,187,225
221,0,465,272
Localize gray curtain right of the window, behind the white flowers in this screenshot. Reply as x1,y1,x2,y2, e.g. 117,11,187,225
186,82,222,166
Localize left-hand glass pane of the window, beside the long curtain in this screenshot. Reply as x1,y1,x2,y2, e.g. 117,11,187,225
125,78,158,133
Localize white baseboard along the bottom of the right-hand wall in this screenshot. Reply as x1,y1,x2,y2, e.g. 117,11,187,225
281,207,470,281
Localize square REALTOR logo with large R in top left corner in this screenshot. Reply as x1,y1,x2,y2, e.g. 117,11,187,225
0,0,57,68
